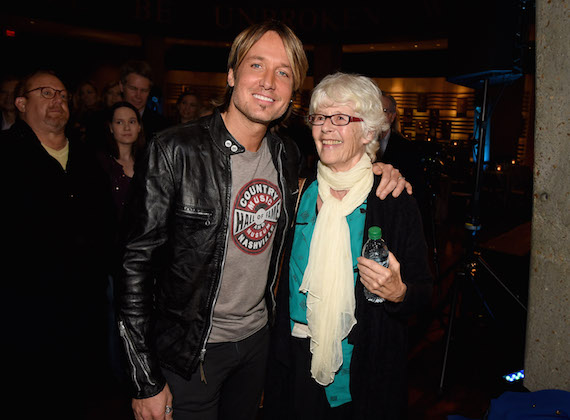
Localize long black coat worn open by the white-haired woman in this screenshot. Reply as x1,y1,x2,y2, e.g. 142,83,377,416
264,173,432,420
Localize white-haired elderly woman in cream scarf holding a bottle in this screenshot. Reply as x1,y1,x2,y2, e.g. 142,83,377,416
264,73,432,420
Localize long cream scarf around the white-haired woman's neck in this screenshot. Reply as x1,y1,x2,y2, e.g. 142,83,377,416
299,153,374,386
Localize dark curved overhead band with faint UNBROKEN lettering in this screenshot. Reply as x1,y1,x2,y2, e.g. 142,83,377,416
2,0,449,43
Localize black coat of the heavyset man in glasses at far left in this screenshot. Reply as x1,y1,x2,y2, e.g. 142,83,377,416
0,120,115,296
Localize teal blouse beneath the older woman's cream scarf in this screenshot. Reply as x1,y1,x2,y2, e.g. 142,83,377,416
289,181,366,407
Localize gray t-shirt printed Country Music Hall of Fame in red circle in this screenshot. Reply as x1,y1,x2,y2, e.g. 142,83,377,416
208,139,282,343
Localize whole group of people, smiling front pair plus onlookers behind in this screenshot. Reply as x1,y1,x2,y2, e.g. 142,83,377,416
0,21,431,420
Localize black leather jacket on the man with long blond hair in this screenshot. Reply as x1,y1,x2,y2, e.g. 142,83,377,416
117,110,299,398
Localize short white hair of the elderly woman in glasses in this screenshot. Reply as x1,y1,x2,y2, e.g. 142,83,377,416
309,72,390,162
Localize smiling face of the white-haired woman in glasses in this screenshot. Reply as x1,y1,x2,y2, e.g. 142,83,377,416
312,103,371,172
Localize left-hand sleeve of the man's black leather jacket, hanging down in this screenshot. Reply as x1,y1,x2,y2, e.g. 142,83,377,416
117,137,175,398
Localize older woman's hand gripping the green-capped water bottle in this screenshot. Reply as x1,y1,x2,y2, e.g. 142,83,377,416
358,252,408,302
